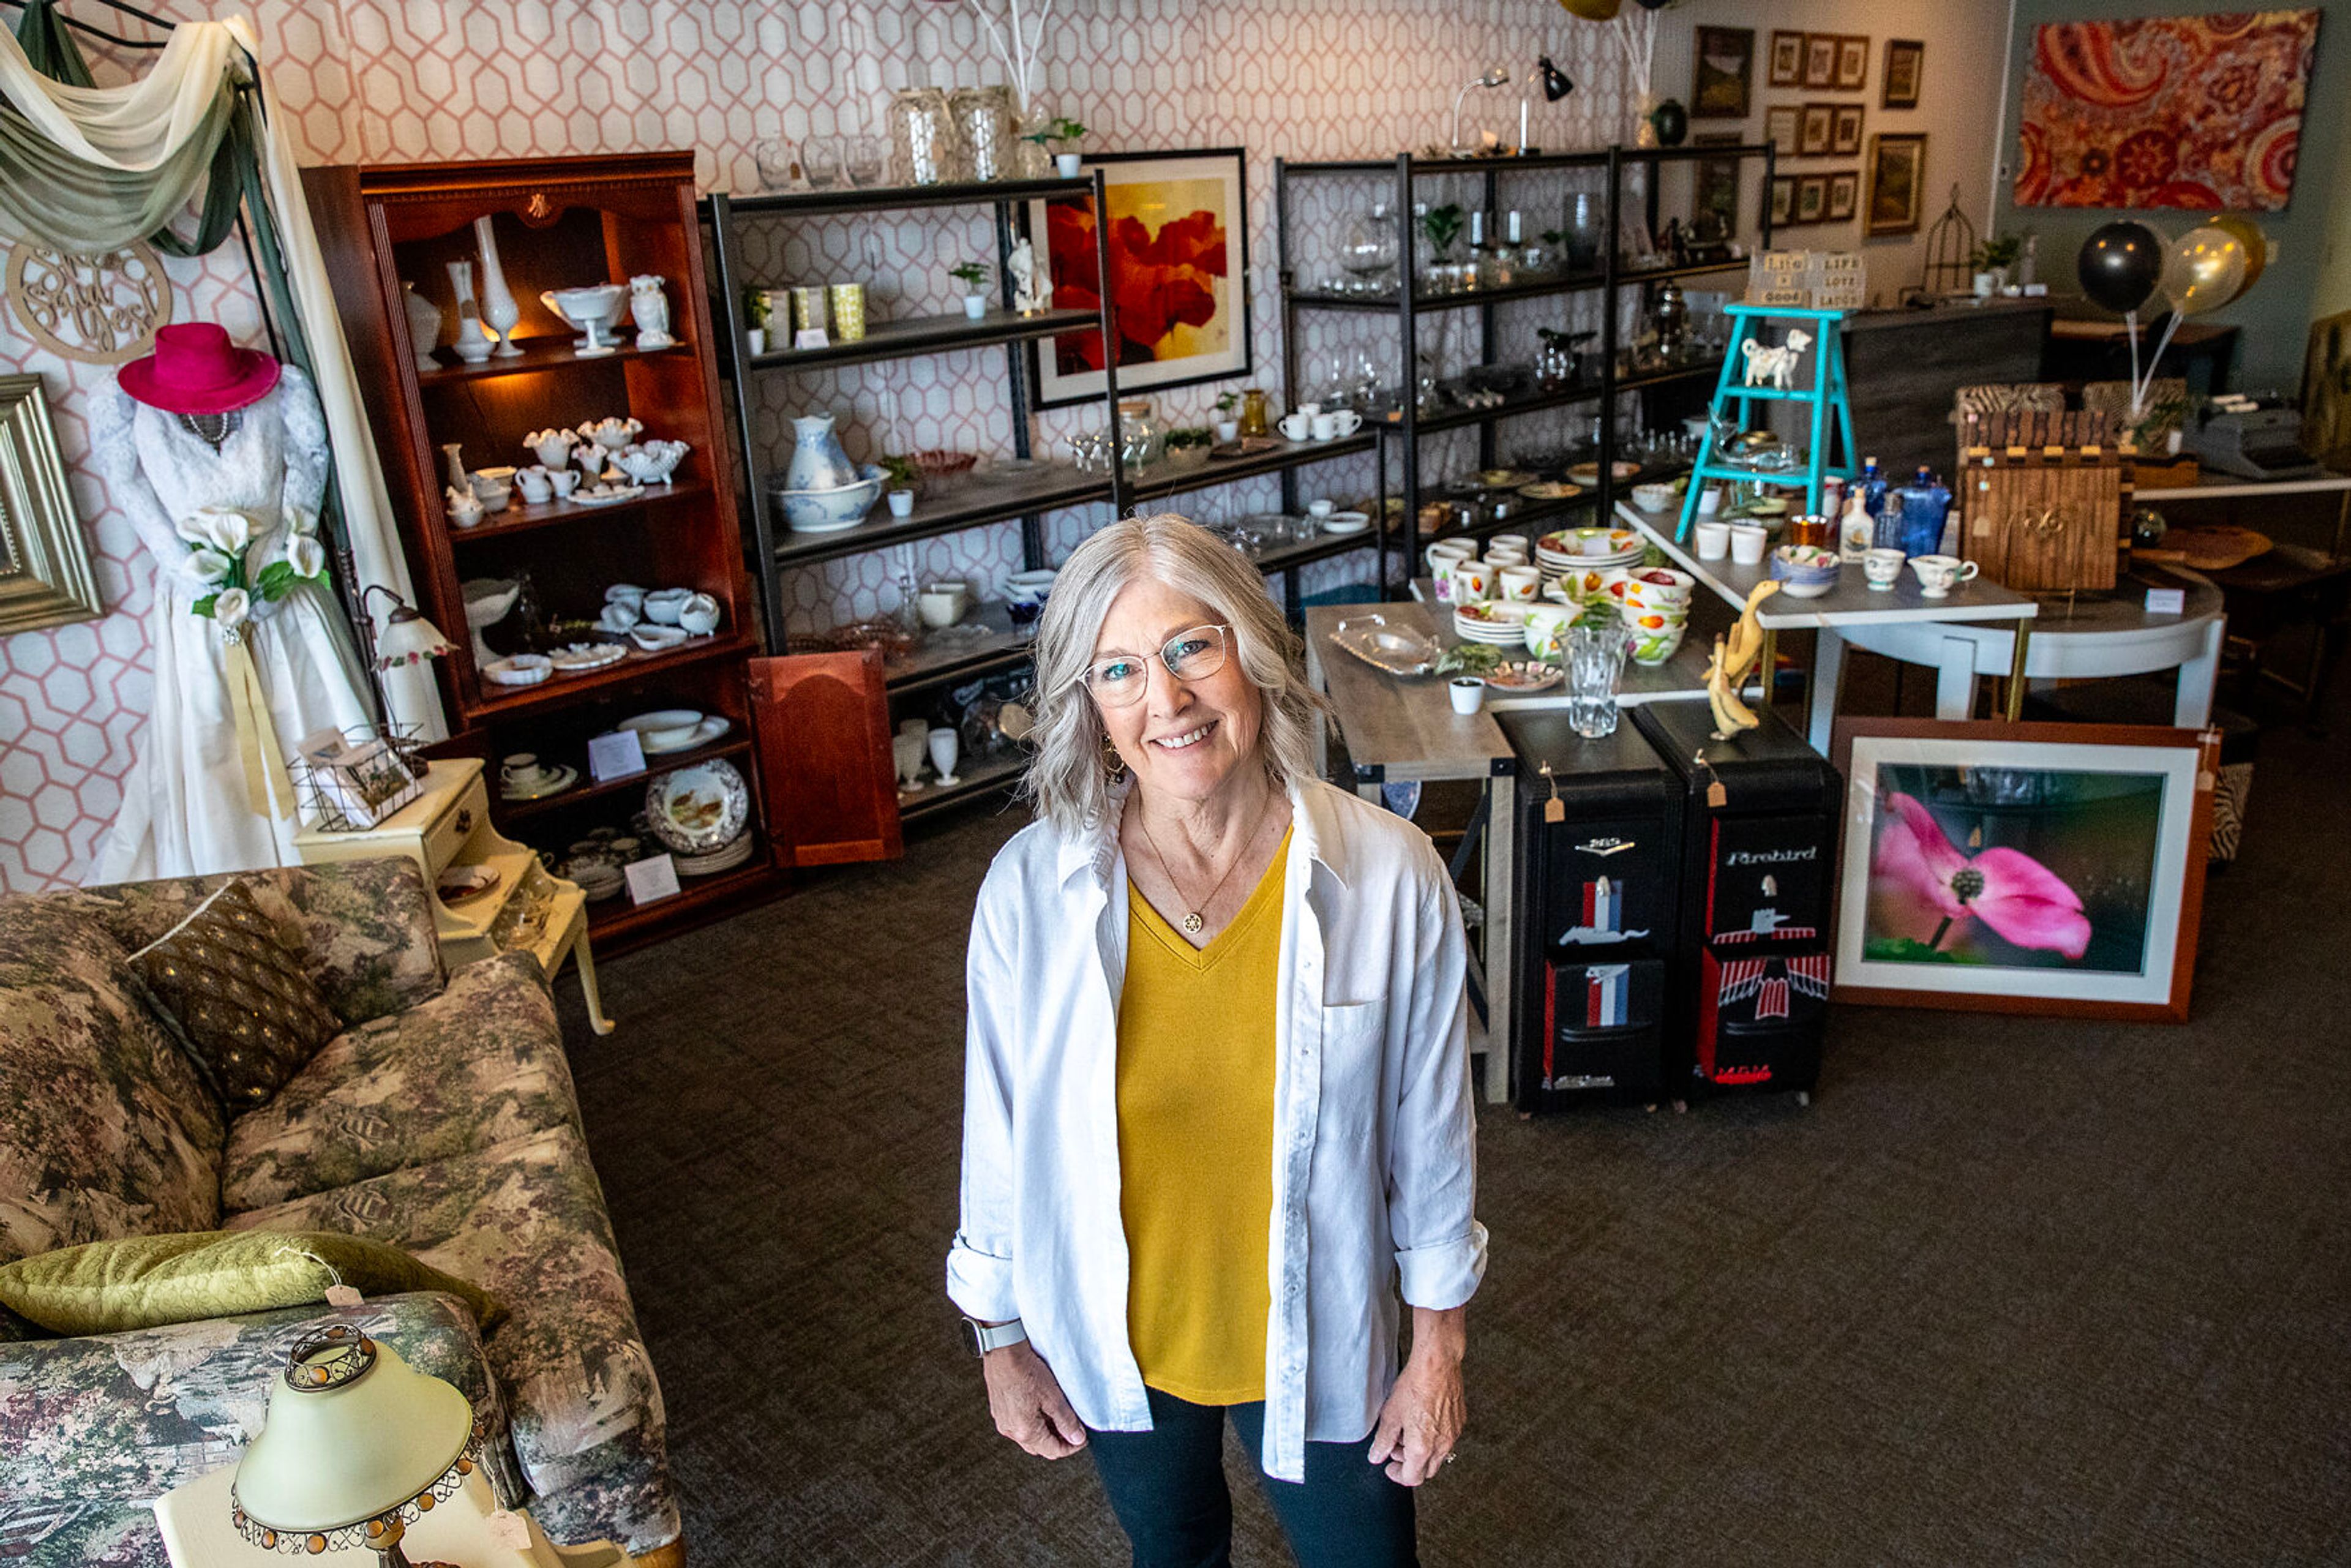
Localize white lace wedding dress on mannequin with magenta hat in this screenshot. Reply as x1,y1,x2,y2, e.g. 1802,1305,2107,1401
89,364,374,884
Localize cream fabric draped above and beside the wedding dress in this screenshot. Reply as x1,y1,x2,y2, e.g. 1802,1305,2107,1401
0,17,449,740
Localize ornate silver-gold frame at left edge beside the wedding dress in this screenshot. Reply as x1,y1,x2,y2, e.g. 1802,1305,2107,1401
0,376,106,637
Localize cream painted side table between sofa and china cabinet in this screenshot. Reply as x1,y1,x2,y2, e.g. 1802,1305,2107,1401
294,757,613,1034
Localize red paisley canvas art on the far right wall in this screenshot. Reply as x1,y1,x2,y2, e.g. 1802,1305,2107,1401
2017,9,2318,212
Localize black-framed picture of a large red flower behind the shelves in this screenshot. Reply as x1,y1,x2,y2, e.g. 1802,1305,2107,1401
1027,148,1251,409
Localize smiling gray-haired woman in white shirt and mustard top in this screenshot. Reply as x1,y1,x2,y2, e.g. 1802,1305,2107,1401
948,517,1486,1568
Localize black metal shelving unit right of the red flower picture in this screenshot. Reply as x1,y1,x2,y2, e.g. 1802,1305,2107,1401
1274,143,1777,590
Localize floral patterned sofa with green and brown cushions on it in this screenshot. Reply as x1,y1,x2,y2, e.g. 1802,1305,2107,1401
0,860,682,1568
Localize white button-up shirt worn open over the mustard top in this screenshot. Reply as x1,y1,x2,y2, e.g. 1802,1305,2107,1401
948,781,1486,1481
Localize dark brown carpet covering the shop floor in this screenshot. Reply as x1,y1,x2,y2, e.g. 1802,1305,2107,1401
566,681,2351,1566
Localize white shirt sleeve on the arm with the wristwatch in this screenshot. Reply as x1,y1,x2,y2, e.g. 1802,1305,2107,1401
948,877,1021,1324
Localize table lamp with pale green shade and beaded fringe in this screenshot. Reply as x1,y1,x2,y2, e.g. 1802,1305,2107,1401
230,1324,482,1568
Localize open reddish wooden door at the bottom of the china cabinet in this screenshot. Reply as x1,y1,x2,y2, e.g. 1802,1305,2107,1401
750,649,905,865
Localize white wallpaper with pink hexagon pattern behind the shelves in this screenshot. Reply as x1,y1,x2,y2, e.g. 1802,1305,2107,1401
0,0,1629,891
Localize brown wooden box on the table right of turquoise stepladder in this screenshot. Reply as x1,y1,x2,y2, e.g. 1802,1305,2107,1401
1959,411,2137,593
